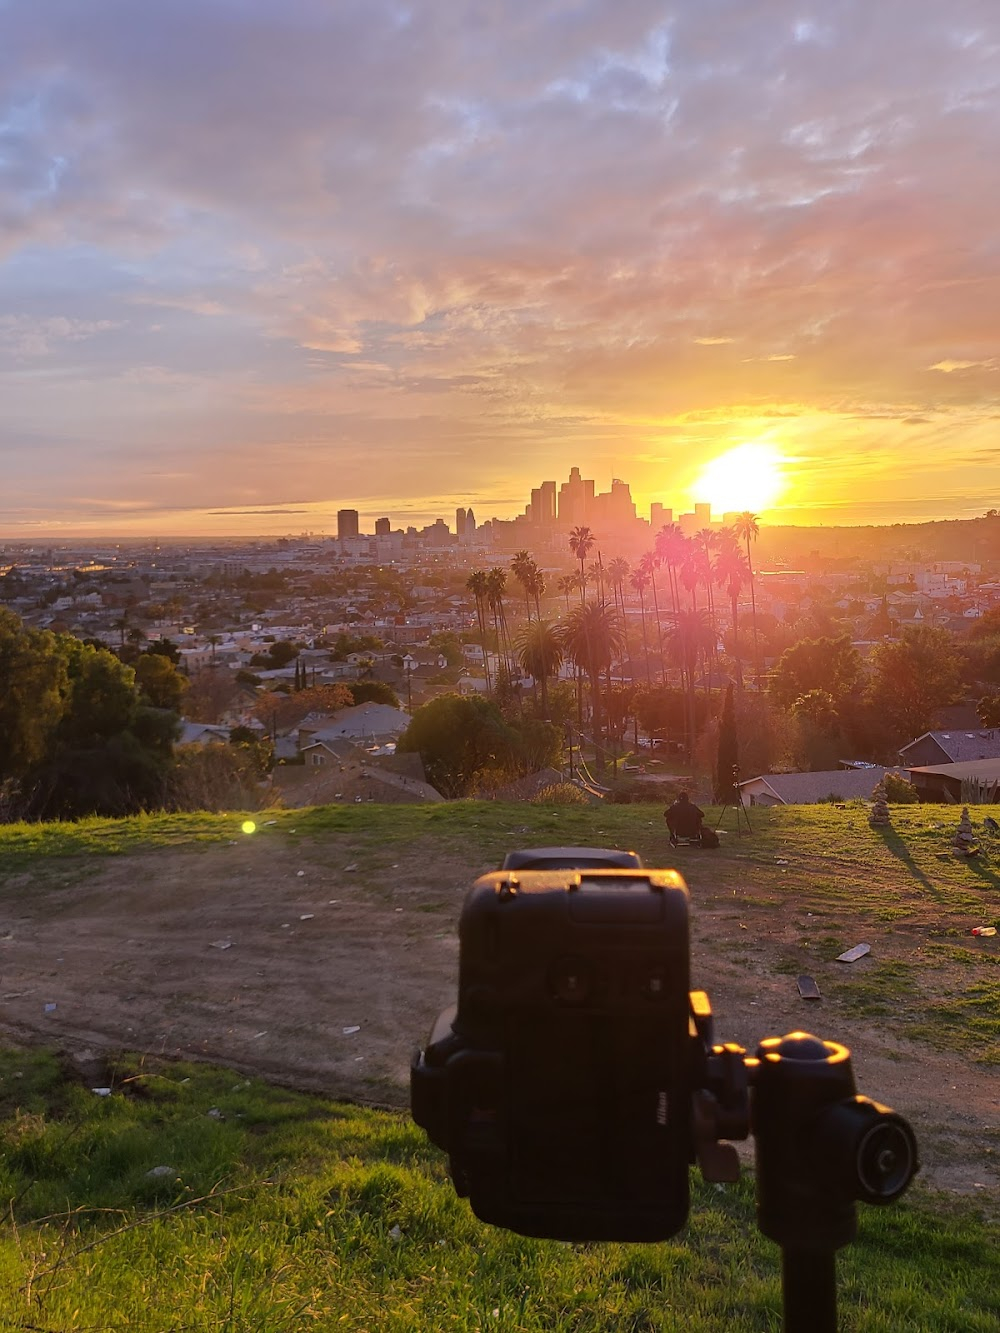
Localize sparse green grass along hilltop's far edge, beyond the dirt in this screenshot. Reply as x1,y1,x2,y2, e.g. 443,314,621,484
0,801,1000,1064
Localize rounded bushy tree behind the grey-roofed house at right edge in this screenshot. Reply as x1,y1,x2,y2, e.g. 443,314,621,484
868,625,960,741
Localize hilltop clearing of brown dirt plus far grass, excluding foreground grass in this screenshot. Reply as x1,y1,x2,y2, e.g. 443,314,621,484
0,802,1000,1192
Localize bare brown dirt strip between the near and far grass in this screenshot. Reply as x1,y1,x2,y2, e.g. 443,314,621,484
0,838,1000,1200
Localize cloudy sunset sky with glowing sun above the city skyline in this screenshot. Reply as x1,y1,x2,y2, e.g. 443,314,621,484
0,0,1000,539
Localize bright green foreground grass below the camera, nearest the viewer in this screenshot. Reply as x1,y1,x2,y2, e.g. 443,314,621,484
0,1050,1000,1333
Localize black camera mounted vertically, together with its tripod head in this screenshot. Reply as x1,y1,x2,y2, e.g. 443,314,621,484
411,849,917,1253
